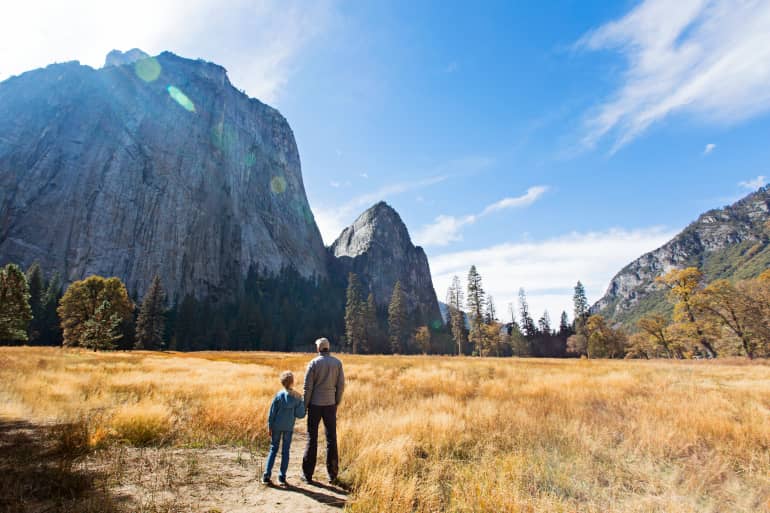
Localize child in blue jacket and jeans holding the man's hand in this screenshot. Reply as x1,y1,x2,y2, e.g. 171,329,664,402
262,371,305,486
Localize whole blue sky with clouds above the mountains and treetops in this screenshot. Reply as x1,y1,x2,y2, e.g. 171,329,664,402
0,0,770,319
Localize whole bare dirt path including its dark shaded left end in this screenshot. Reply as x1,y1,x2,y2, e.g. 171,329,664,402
0,419,347,513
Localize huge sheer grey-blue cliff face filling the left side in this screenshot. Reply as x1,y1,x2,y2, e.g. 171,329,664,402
0,52,328,300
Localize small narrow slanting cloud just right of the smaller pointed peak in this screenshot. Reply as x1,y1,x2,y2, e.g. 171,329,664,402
415,185,548,246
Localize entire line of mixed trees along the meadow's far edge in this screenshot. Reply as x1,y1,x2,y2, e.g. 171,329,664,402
0,264,770,358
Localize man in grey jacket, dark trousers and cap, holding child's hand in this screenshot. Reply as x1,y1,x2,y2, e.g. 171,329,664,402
301,338,345,483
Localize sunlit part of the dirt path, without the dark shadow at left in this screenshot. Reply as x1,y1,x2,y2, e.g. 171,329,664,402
108,433,347,513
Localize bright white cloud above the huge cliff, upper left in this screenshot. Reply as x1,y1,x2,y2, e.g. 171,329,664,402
0,0,335,102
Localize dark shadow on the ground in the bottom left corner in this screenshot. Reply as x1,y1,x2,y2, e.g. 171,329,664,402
0,418,120,513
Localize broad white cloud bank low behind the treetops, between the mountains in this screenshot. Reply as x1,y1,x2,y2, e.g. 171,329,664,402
430,227,676,319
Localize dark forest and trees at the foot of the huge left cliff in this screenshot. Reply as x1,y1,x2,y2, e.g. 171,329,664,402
0,264,344,351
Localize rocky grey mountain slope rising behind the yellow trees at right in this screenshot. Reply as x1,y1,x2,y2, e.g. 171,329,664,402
591,186,770,324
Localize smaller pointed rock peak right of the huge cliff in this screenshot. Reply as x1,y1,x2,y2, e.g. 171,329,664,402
329,202,442,325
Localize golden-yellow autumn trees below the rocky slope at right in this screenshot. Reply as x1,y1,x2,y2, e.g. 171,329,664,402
568,267,770,359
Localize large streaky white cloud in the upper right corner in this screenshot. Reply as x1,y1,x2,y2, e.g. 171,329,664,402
577,0,770,151
